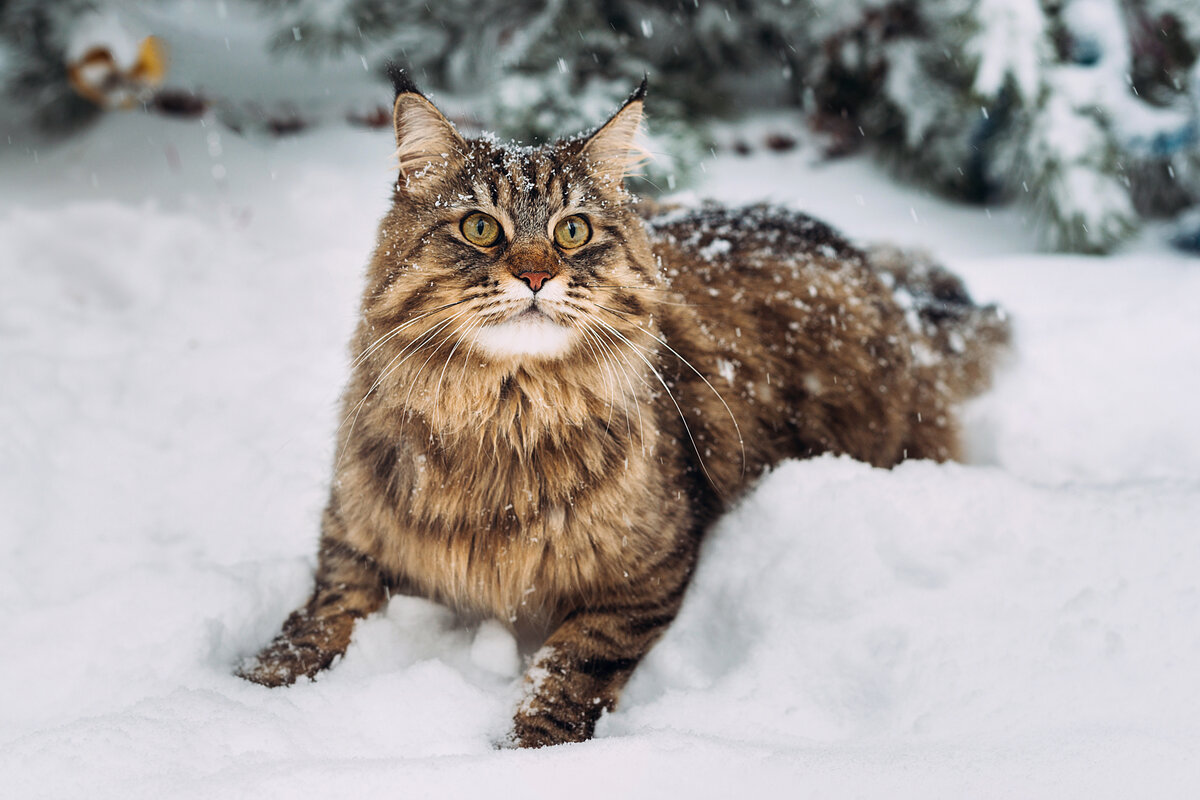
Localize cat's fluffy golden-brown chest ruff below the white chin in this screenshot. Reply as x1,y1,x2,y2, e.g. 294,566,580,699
346,363,670,620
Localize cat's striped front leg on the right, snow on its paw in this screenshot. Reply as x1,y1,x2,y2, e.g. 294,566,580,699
512,570,690,747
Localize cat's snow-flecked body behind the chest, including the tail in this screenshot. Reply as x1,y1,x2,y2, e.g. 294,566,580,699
644,203,1003,474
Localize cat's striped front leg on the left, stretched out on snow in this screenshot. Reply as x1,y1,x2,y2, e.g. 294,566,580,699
238,511,388,686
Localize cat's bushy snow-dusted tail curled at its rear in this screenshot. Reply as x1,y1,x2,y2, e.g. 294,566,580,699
866,245,1012,403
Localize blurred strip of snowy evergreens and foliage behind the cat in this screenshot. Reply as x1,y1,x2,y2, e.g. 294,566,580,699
7,0,1200,253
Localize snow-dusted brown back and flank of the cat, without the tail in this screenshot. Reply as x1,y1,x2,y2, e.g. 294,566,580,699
646,203,911,482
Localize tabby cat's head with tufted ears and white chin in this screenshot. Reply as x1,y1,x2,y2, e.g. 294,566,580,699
364,74,658,363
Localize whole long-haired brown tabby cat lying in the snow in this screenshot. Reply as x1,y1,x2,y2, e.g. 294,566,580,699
240,73,1007,746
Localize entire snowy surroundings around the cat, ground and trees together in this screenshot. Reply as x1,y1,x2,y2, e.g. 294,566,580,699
7,0,1200,800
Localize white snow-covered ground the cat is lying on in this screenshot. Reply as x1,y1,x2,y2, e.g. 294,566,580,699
0,97,1200,799
